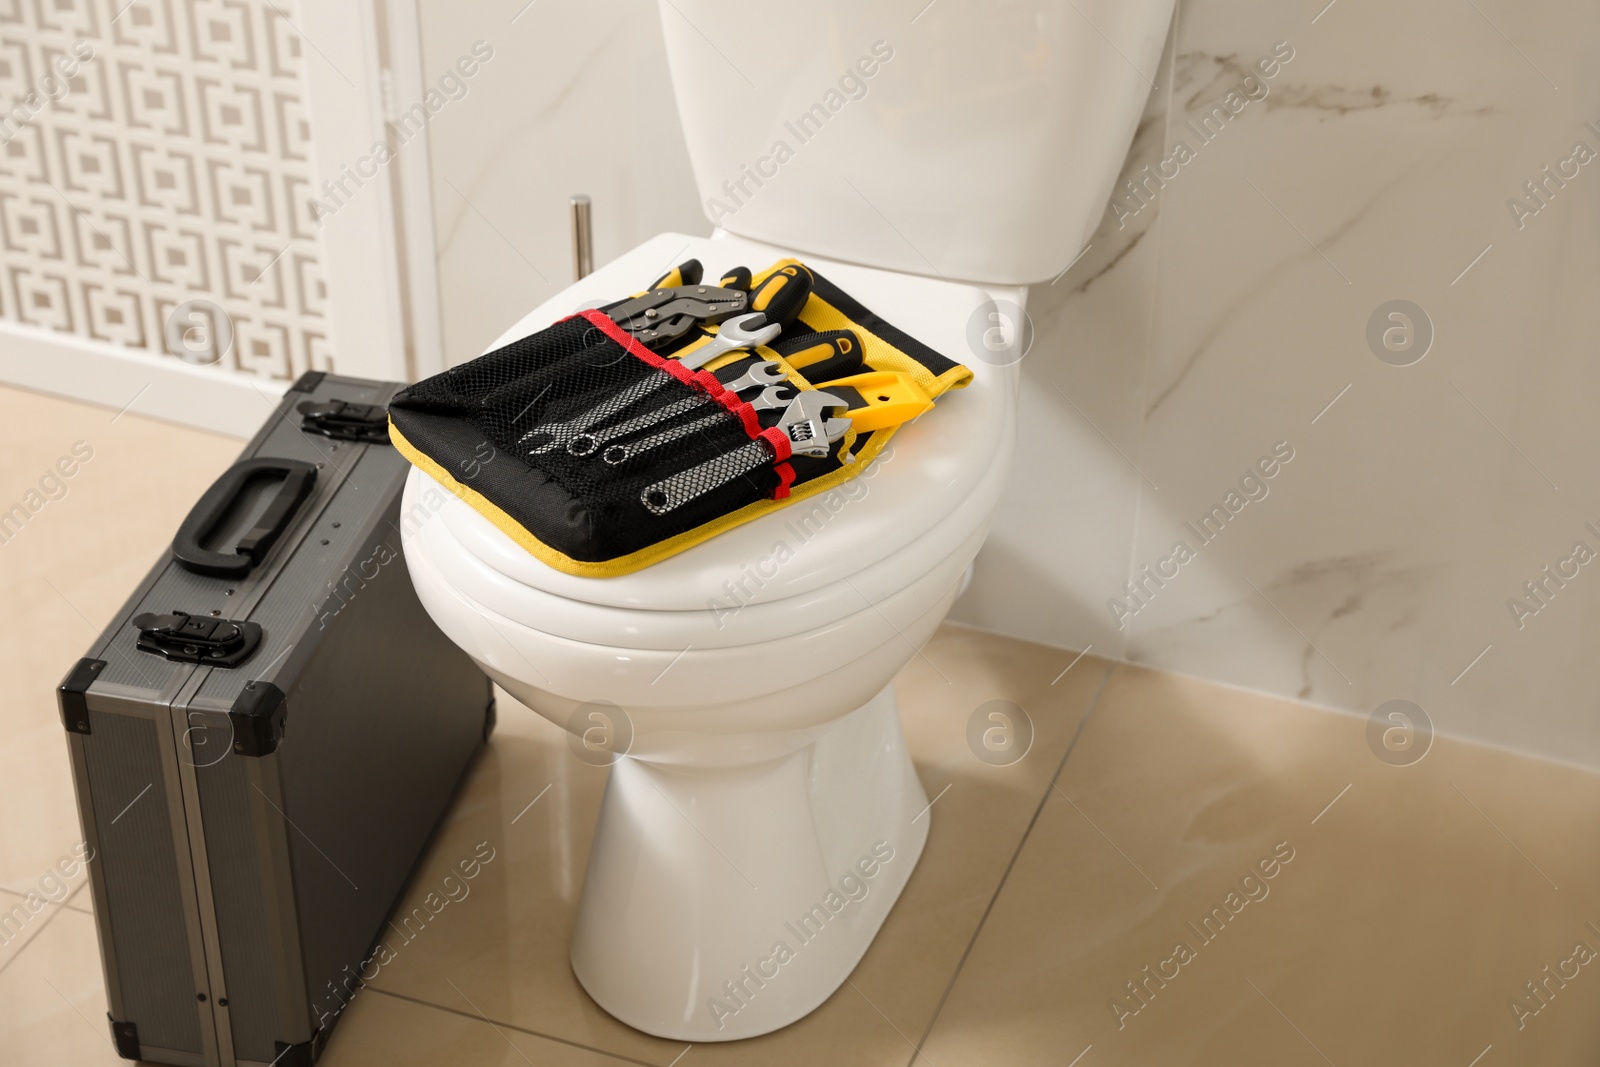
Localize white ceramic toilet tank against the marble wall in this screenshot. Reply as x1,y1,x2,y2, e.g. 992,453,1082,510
659,0,1173,285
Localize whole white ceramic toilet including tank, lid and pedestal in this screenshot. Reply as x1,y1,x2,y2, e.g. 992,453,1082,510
405,0,1173,1041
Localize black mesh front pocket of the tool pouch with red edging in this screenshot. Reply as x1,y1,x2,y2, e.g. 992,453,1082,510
380,310,794,576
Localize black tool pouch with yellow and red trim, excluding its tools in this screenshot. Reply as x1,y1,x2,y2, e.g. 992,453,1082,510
389,261,970,577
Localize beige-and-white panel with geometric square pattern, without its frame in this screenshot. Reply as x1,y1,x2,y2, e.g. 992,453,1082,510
0,0,331,378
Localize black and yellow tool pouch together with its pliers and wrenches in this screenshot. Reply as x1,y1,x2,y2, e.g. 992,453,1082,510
389,259,970,576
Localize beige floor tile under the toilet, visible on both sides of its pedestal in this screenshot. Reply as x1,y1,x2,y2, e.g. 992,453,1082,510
363,627,1107,1064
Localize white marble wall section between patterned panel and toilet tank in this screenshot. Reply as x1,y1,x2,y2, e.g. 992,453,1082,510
421,0,710,363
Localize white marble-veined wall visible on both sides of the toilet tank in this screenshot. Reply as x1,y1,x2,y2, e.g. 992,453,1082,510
422,0,1600,766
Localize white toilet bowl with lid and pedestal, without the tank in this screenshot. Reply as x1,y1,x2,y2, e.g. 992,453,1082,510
402,234,1021,1041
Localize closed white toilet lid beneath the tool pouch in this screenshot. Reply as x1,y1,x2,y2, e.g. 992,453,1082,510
425,234,1021,624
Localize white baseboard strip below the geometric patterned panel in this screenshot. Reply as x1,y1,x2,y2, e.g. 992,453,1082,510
0,322,288,438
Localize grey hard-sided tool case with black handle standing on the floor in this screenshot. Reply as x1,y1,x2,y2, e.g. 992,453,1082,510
58,373,494,1067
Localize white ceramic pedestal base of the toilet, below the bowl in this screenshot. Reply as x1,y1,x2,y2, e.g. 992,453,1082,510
571,688,933,1041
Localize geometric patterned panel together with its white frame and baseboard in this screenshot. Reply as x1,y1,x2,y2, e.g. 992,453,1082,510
0,0,437,425
